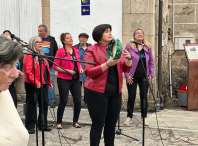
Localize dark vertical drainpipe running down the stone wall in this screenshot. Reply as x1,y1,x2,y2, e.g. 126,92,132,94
158,0,164,109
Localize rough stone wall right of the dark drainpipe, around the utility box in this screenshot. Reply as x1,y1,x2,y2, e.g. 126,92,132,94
163,0,198,96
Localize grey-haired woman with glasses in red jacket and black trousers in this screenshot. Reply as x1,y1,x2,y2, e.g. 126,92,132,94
23,36,53,134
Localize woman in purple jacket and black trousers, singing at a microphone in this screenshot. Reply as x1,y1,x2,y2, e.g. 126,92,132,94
124,29,154,126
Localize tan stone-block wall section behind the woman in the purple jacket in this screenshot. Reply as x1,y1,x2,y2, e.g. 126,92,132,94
122,0,157,107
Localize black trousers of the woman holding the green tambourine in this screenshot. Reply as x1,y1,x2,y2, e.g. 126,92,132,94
85,88,122,146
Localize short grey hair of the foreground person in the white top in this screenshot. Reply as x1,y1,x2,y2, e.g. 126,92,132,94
0,37,23,68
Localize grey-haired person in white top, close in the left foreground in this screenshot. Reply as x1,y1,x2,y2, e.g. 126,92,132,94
0,37,29,146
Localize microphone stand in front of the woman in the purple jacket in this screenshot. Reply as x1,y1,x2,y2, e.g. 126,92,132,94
135,43,156,146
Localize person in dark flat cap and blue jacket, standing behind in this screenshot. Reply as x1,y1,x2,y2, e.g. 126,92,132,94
75,33,91,108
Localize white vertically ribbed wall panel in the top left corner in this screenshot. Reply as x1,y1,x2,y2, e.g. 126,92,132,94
0,0,42,43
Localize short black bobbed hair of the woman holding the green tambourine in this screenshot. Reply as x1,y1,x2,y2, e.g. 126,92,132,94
92,24,111,43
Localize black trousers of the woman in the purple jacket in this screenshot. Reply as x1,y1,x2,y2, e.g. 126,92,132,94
127,78,148,118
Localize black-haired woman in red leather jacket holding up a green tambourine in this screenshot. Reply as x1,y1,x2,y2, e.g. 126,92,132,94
84,24,132,146
